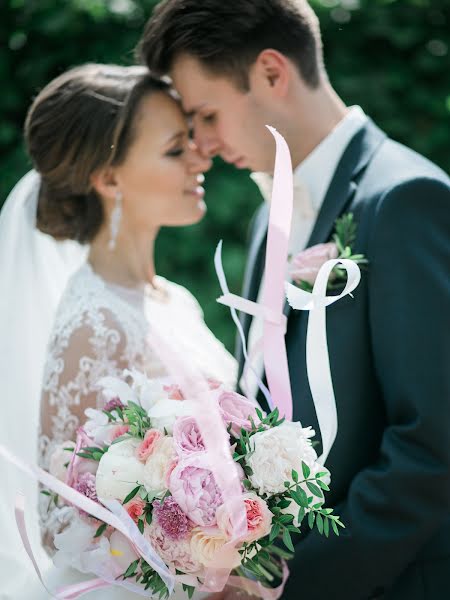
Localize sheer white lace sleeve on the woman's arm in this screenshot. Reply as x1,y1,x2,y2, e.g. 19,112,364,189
39,310,134,553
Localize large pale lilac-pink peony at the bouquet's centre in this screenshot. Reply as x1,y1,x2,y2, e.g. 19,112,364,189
169,454,223,527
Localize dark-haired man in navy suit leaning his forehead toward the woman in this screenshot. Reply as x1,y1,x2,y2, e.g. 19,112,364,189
140,0,450,600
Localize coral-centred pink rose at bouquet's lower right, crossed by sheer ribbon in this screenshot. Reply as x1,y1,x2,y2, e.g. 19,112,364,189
216,492,273,543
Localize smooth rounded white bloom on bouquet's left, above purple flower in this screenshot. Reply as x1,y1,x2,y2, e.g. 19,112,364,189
96,439,144,501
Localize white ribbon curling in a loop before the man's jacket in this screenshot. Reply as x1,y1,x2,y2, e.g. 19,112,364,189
285,259,361,464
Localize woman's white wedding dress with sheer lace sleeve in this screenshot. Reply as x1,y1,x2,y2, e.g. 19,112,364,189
33,263,237,600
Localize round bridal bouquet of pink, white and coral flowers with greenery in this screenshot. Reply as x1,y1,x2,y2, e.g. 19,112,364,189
44,372,343,597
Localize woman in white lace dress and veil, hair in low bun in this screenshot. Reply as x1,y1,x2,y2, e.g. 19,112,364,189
0,64,236,600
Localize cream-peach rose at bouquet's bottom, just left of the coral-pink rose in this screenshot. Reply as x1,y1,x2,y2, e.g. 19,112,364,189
191,527,241,569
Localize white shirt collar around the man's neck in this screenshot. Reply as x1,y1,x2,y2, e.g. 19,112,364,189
251,106,367,212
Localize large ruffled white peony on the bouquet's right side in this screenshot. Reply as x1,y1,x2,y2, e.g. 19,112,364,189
246,421,317,494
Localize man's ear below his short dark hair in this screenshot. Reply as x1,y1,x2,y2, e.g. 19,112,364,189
250,49,291,97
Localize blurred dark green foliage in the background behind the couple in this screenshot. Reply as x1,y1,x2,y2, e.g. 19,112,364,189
0,0,450,348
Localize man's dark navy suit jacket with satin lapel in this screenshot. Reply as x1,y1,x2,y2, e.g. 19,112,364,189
240,120,450,600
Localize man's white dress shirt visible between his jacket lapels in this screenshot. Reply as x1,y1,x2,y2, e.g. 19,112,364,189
239,106,367,398
